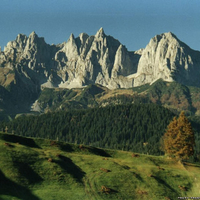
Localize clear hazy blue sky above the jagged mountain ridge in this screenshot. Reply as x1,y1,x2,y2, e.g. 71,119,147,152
0,0,200,51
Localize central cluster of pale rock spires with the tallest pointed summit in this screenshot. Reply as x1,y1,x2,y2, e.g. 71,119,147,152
55,28,137,88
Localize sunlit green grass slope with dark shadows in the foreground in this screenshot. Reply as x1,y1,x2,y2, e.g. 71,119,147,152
0,133,200,200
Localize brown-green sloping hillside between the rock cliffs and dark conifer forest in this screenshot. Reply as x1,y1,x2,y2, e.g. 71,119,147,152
32,80,200,116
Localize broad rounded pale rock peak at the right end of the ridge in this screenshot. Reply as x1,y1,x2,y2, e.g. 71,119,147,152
134,32,200,87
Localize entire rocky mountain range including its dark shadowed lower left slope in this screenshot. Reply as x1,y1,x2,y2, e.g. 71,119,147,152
0,28,200,113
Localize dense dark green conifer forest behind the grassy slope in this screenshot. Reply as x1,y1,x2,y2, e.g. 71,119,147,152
1,104,177,155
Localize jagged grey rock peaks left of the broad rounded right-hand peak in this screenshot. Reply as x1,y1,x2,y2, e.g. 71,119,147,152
0,28,140,89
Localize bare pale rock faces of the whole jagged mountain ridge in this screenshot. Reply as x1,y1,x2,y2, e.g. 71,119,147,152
0,28,200,94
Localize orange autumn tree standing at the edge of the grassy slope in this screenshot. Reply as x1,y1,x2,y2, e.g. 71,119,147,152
163,112,195,159
